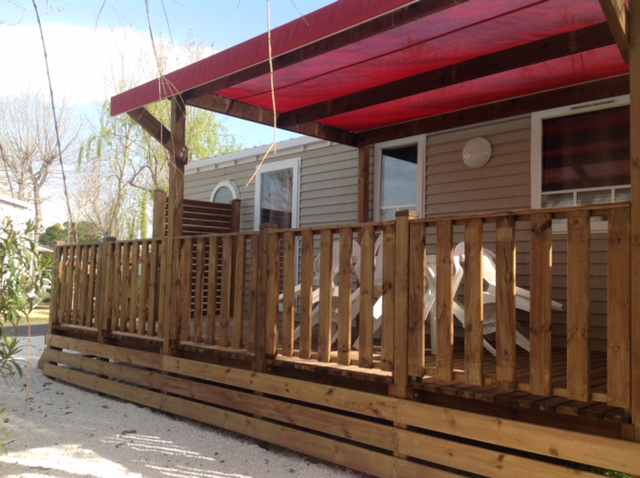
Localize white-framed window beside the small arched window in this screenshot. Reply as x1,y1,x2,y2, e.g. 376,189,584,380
254,159,300,230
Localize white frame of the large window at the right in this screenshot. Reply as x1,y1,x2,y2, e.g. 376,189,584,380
531,95,629,209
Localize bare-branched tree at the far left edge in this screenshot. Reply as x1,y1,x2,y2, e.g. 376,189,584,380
0,94,79,242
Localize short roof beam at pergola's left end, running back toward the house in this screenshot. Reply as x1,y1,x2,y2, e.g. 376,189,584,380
185,94,357,146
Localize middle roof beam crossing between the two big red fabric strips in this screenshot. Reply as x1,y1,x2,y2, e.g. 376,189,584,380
278,23,613,128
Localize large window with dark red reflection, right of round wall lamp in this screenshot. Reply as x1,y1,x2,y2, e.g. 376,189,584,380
531,96,631,208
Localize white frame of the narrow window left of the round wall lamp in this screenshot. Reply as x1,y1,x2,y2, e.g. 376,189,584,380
373,134,427,221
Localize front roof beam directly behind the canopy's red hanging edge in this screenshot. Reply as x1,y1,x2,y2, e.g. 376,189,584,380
180,0,467,99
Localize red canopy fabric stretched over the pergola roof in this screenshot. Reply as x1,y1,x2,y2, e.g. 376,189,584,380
112,0,628,140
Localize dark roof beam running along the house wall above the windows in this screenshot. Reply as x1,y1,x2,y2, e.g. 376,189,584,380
359,75,629,146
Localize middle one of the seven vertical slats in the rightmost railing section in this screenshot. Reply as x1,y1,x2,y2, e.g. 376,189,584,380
496,217,516,389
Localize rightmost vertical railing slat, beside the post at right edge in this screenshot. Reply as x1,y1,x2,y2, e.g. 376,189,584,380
607,209,631,408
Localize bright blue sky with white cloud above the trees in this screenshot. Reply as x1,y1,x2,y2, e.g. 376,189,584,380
0,0,333,223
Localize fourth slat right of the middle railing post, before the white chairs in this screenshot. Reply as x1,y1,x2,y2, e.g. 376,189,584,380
338,227,353,365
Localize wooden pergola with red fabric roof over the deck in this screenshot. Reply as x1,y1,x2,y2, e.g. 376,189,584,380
111,0,640,432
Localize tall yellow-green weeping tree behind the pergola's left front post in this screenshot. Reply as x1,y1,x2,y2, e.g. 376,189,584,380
76,34,242,239
